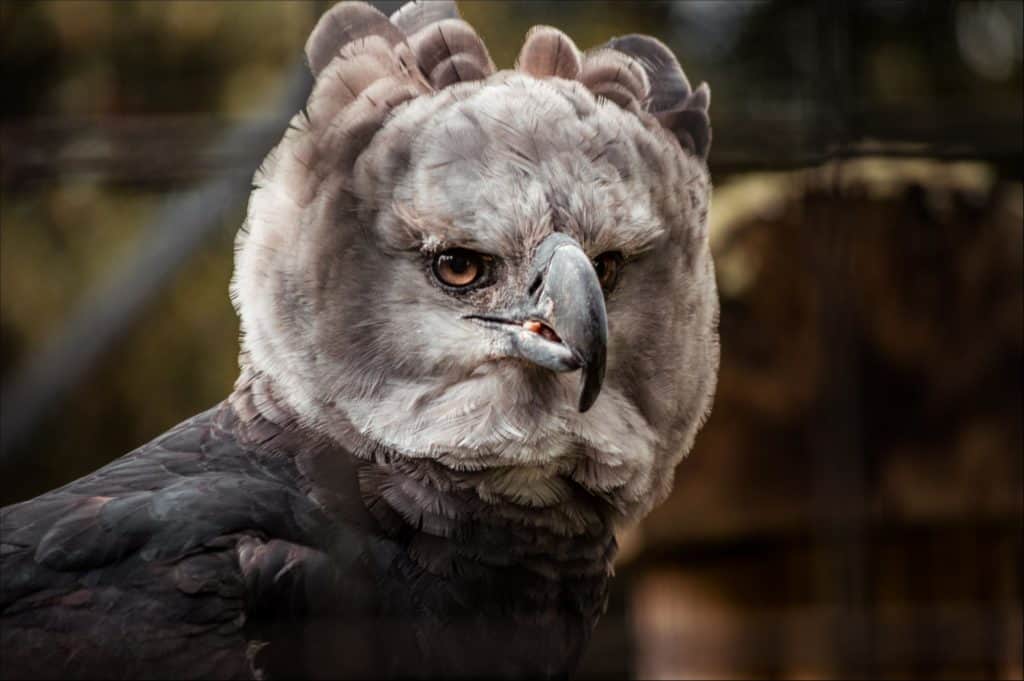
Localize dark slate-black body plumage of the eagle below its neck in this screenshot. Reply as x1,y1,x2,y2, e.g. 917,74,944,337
0,374,614,678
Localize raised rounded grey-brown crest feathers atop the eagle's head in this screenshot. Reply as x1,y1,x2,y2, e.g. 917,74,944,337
299,0,711,183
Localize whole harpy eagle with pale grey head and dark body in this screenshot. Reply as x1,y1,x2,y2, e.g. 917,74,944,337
0,2,718,678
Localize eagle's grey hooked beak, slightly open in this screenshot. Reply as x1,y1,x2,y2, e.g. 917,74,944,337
464,233,608,413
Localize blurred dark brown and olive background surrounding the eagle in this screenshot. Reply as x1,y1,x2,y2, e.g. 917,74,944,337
0,0,1024,678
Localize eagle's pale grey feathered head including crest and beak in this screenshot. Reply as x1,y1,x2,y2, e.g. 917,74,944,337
231,2,719,518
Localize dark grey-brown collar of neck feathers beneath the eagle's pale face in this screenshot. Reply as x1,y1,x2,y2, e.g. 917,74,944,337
228,369,616,580
